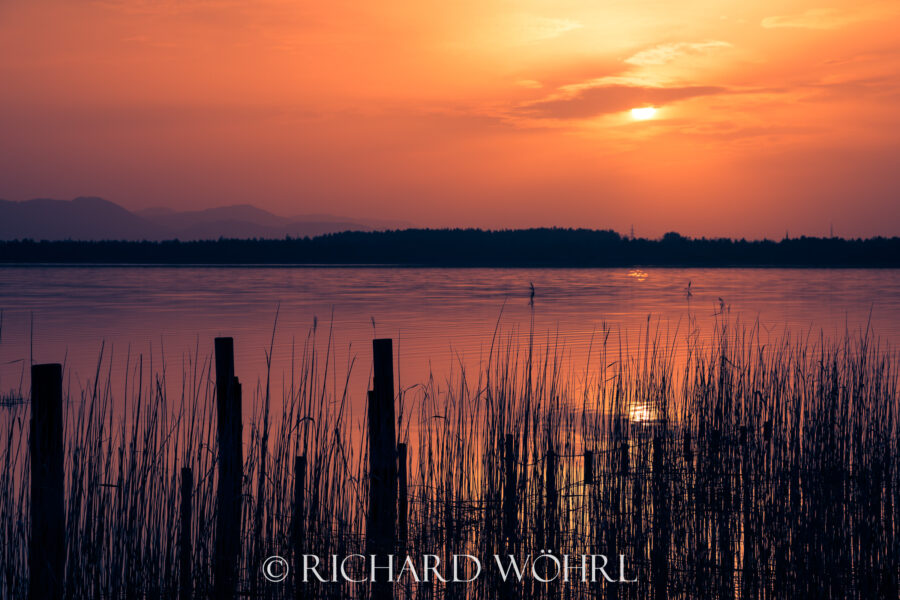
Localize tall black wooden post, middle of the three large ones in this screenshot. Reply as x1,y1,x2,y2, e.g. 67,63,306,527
213,337,244,600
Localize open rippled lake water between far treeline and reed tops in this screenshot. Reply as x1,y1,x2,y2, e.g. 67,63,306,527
0,267,900,404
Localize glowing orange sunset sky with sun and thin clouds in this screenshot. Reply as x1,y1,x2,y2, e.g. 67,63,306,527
0,0,900,239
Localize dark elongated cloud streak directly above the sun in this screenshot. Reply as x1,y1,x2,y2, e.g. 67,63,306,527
519,77,730,119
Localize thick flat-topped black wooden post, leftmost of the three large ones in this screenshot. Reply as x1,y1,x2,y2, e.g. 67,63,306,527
28,364,66,600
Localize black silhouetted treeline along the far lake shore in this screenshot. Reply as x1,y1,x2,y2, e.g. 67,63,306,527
0,229,900,267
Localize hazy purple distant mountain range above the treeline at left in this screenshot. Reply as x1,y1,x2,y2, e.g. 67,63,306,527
0,198,404,240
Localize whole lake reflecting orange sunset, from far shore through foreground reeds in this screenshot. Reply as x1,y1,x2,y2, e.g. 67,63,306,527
0,267,900,600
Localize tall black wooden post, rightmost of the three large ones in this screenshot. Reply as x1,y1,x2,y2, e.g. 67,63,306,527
366,339,397,600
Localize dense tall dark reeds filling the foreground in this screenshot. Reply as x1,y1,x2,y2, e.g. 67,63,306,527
0,318,900,599
